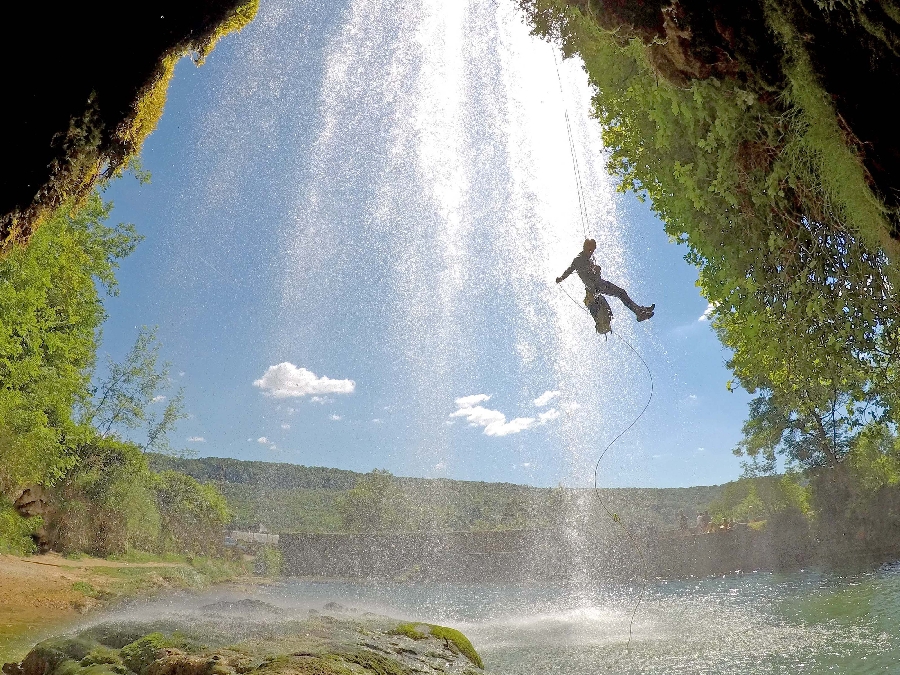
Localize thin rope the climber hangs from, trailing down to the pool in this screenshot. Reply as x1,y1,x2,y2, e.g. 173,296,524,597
553,50,653,651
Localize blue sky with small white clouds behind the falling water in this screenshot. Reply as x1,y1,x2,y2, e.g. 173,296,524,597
96,0,748,486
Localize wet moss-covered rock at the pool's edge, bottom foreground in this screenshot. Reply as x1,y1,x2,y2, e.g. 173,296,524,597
3,600,483,675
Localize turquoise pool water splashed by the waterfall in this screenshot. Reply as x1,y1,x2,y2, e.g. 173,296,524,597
250,567,900,675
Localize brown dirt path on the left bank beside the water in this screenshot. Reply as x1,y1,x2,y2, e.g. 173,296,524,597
0,553,190,663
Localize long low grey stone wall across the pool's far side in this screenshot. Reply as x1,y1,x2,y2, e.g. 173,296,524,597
280,527,824,583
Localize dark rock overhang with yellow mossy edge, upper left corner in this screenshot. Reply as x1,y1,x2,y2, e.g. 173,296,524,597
0,0,259,254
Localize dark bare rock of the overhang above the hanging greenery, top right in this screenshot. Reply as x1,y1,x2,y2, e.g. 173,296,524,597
548,0,900,239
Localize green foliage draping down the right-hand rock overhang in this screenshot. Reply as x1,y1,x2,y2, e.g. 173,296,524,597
521,0,900,446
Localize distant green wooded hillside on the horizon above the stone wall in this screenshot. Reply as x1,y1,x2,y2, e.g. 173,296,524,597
150,455,723,533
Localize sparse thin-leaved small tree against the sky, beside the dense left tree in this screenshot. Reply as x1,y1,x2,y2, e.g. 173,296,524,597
81,326,187,452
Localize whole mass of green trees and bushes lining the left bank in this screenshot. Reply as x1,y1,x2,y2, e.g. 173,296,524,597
0,194,239,555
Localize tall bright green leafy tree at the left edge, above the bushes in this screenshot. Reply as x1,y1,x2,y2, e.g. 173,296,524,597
0,195,140,493
